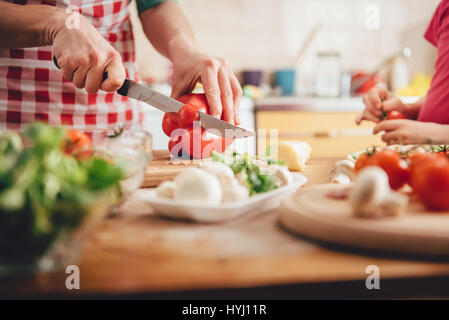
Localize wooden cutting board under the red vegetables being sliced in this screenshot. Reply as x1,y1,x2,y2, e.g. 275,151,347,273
142,150,199,188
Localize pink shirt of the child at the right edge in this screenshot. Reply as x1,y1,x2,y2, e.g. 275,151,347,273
418,0,449,124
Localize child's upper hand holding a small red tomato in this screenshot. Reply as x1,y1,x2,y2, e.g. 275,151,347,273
355,87,408,124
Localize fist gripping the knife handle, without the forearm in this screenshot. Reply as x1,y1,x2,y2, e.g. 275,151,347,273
53,15,126,93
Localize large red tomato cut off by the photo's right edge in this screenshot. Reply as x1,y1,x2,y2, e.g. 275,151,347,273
412,156,449,211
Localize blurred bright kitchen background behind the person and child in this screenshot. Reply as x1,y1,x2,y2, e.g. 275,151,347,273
132,0,439,156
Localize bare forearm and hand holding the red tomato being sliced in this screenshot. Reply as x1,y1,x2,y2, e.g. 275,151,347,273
139,1,242,124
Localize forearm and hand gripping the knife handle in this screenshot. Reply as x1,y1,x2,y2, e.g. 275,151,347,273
0,1,125,93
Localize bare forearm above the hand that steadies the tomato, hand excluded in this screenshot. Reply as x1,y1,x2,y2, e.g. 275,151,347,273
139,1,196,61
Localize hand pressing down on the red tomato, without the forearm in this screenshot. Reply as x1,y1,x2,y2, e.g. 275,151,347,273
172,46,242,124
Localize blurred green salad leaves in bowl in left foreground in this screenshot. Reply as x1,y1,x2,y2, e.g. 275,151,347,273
0,123,124,264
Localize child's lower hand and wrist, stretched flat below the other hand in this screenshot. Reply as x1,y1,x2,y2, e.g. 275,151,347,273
374,120,449,145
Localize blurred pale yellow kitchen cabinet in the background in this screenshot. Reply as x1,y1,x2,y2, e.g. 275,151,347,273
256,99,384,157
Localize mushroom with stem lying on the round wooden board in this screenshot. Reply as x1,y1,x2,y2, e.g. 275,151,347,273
350,167,408,218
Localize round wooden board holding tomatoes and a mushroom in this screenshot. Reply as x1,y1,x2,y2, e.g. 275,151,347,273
279,184,449,256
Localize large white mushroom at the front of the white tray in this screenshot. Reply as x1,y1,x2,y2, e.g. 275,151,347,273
174,168,223,204
